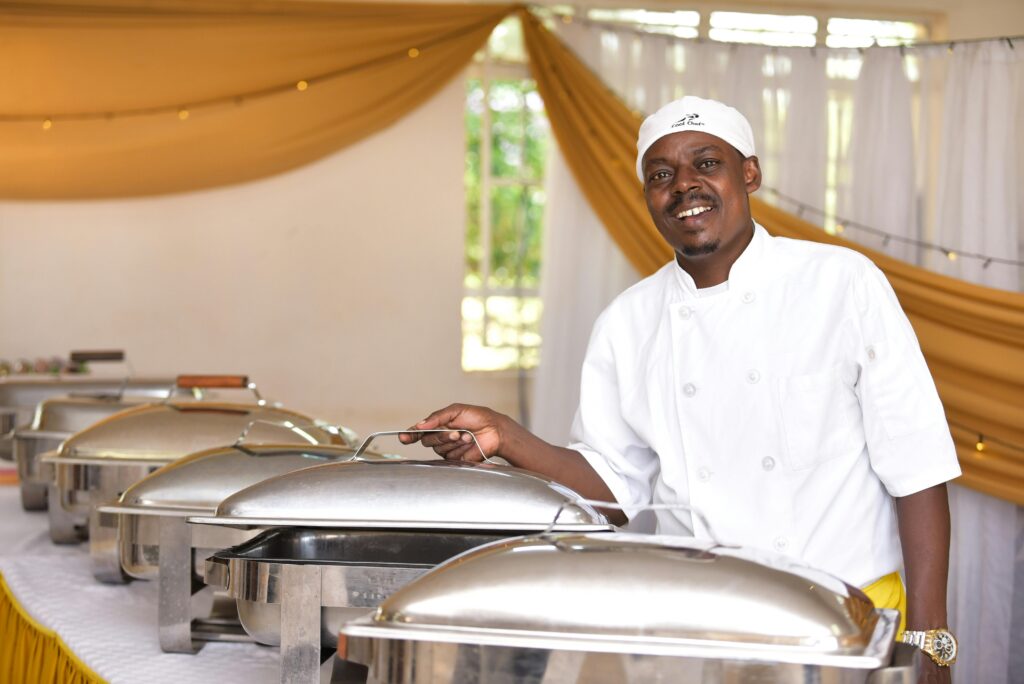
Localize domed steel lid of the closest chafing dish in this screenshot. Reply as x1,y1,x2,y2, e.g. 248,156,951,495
341,533,899,669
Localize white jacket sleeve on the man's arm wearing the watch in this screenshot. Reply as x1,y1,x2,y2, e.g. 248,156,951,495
852,263,961,497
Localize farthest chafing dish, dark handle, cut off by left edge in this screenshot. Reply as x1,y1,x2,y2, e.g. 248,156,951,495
0,350,174,461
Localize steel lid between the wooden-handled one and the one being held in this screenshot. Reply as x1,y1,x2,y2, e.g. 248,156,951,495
100,444,398,515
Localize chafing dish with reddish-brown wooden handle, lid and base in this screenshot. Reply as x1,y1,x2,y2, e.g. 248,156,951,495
41,376,344,548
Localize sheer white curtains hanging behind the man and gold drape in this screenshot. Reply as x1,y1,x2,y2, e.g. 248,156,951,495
534,17,1024,684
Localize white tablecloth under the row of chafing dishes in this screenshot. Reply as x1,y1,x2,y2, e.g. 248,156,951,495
0,486,331,684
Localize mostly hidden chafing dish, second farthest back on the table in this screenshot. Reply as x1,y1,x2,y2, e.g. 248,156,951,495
12,396,155,511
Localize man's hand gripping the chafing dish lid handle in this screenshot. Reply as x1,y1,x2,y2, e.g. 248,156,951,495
398,403,509,461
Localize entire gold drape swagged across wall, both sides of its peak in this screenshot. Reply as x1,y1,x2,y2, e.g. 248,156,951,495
0,0,1024,504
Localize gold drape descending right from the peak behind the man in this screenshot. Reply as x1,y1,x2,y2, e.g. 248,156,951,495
521,11,1024,504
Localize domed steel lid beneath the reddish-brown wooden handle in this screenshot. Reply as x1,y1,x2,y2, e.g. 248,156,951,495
44,401,344,463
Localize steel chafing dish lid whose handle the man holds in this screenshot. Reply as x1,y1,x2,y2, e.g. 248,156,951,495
189,461,611,531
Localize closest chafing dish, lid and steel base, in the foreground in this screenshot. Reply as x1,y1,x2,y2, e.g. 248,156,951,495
338,532,913,684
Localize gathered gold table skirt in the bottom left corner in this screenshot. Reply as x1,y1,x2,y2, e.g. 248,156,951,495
0,575,103,684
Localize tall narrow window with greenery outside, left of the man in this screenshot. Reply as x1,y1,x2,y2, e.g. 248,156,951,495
462,18,551,371
